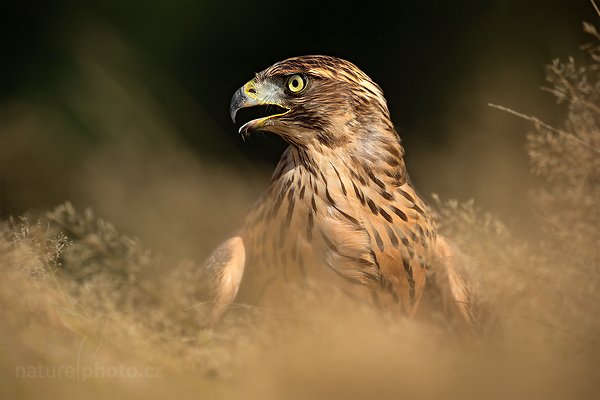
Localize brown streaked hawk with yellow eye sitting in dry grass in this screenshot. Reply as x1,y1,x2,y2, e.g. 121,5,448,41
205,55,486,332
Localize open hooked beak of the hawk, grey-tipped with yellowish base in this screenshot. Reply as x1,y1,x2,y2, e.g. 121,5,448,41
229,79,290,137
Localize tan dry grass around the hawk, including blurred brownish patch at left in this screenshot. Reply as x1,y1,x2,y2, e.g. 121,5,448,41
0,17,600,399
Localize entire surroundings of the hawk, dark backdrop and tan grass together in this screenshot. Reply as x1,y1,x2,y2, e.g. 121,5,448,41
0,0,600,399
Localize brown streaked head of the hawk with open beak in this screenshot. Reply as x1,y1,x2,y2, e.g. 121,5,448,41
230,56,395,148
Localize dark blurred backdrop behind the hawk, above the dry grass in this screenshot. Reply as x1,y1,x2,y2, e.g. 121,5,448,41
0,0,594,256
